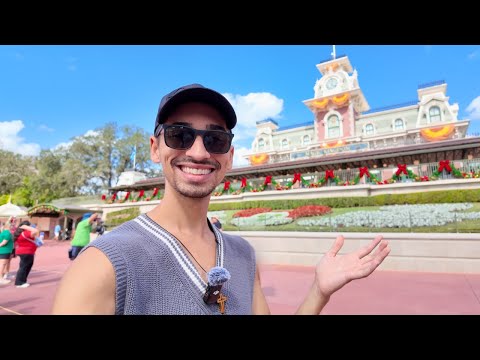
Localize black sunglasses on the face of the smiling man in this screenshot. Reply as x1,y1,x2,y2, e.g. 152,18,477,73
158,125,233,154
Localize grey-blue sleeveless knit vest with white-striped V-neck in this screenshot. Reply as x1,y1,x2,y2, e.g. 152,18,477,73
83,214,256,315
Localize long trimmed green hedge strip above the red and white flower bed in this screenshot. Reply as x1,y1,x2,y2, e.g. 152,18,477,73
208,190,480,211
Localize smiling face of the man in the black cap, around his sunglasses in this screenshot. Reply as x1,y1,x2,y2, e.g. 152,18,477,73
150,103,233,198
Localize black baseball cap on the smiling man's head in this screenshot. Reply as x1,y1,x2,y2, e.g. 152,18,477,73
153,84,237,136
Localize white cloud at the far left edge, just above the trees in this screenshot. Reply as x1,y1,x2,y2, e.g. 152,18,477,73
0,120,41,156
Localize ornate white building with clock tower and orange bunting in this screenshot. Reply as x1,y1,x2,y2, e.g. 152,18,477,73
246,56,469,165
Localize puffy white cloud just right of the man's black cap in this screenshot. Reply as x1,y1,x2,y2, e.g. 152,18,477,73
223,92,283,141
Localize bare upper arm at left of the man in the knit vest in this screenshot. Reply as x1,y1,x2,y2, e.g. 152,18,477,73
52,247,115,315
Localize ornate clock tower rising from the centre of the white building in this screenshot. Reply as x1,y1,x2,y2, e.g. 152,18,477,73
303,52,370,146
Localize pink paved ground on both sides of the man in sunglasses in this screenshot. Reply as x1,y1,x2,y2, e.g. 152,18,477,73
0,241,480,315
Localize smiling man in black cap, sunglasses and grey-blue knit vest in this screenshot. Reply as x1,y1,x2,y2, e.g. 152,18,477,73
52,84,390,314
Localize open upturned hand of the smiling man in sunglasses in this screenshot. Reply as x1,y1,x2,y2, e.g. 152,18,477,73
315,235,390,298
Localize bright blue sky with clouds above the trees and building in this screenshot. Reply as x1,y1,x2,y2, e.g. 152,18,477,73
0,45,480,166
